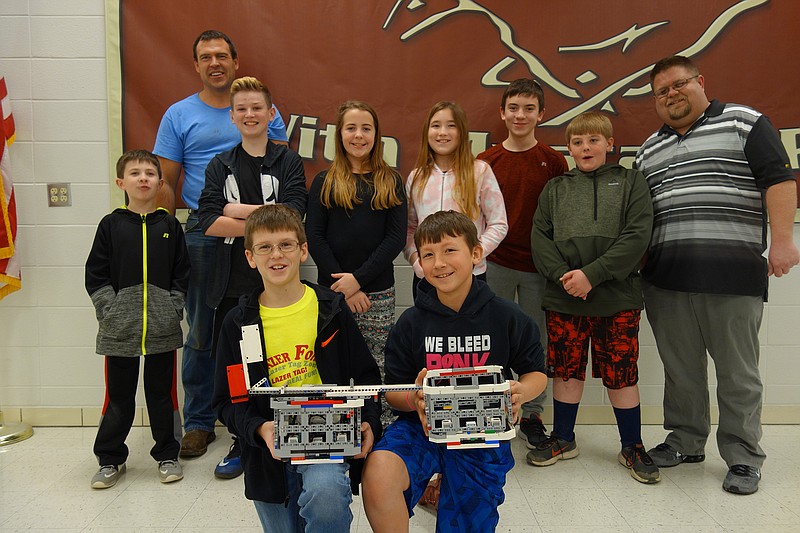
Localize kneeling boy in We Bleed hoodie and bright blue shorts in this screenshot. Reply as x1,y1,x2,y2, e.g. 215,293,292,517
364,211,547,533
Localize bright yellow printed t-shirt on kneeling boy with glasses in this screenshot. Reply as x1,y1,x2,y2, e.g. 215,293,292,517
258,286,322,387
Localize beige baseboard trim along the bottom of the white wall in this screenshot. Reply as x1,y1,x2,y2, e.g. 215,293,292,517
2,405,800,427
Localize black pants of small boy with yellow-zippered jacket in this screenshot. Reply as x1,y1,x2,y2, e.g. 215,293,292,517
94,350,181,466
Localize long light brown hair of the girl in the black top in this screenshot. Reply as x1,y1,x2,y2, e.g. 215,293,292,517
319,100,403,210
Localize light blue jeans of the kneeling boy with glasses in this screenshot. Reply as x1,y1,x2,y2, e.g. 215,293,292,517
253,463,353,533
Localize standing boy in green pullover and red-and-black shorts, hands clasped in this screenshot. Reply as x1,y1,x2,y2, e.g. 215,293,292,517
527,112,661,483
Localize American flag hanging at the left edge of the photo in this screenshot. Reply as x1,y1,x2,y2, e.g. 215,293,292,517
0,76,22,300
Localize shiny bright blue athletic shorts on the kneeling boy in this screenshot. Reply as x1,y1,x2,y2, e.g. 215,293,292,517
373,418,514,533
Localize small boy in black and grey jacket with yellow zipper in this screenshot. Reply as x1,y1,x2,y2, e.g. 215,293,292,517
86,150,189,489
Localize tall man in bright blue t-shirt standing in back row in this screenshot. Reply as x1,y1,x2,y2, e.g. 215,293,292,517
153,30,288,477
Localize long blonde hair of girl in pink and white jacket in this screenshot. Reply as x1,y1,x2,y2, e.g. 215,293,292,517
409,102,480,220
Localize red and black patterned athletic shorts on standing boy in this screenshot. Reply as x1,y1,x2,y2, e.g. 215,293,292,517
546,309,641,389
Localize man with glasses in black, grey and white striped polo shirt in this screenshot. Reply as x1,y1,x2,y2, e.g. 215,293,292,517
636,56,800,494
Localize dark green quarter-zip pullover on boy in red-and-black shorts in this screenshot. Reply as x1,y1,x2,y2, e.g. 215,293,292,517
531,164,653,316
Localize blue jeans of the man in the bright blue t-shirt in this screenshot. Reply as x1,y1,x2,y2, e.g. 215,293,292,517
181,212,217,431
